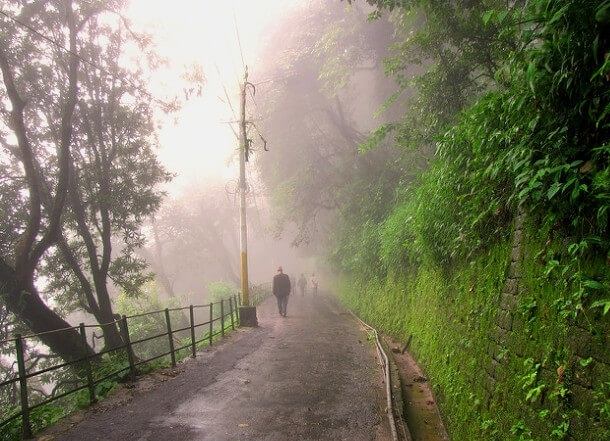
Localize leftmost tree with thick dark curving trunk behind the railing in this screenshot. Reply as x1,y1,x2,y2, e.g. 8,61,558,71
0,2,90,360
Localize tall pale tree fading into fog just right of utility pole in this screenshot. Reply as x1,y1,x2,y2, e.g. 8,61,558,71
251,2,397,244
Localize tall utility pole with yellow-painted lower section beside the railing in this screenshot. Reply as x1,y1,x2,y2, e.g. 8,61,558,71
239,66,258,327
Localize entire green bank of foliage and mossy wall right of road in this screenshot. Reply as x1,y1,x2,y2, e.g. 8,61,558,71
332,0,610,440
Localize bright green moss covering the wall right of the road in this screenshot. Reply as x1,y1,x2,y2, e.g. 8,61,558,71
340,226,610,441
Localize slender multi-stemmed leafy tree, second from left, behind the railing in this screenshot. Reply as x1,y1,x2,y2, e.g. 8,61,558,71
44,11,171,347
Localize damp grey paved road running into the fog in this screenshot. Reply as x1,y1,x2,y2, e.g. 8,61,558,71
41,295,388,441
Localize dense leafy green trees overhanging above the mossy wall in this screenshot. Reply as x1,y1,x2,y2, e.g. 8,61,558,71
334,0,608,275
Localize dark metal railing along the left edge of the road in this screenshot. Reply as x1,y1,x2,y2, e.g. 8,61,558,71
0,296,252,438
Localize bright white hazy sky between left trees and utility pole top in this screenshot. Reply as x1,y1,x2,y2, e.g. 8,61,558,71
129,0,306,191
